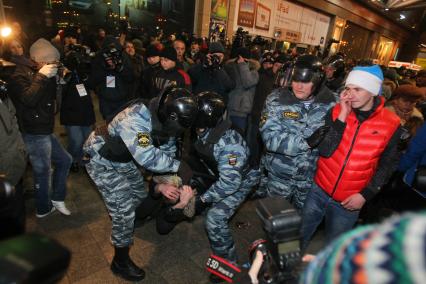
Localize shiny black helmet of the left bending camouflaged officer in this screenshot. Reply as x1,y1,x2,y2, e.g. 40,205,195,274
158,87,197,135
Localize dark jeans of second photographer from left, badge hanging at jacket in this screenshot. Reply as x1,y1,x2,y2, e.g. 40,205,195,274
65,125,92,164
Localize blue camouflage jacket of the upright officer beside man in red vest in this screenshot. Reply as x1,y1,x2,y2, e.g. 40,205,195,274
260,87,335,180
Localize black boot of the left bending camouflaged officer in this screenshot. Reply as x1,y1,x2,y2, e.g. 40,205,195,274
111,247,145,281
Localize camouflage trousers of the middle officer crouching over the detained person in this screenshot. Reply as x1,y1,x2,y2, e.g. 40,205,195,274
206,170,260,262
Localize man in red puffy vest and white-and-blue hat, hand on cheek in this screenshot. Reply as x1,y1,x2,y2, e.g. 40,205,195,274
302,65,400,250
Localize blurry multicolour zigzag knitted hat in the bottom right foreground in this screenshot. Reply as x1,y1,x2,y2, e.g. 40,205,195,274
300,212,426,284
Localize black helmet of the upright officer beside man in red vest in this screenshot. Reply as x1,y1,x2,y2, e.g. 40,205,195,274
290,55,324,93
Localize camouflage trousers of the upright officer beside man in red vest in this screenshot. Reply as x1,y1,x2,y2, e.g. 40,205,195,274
266,172,314,210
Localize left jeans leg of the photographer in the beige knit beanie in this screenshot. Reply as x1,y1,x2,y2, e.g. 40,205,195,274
23,134,52,214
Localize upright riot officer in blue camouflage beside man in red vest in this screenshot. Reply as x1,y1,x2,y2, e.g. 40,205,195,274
260,55,335,209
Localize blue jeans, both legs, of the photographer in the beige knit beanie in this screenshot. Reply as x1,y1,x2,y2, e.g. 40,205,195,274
23,134,72,214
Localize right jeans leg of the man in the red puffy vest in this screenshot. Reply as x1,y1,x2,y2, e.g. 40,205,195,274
325,200,359,243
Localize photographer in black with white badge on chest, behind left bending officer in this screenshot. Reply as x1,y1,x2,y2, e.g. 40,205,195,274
90,36,135,120
